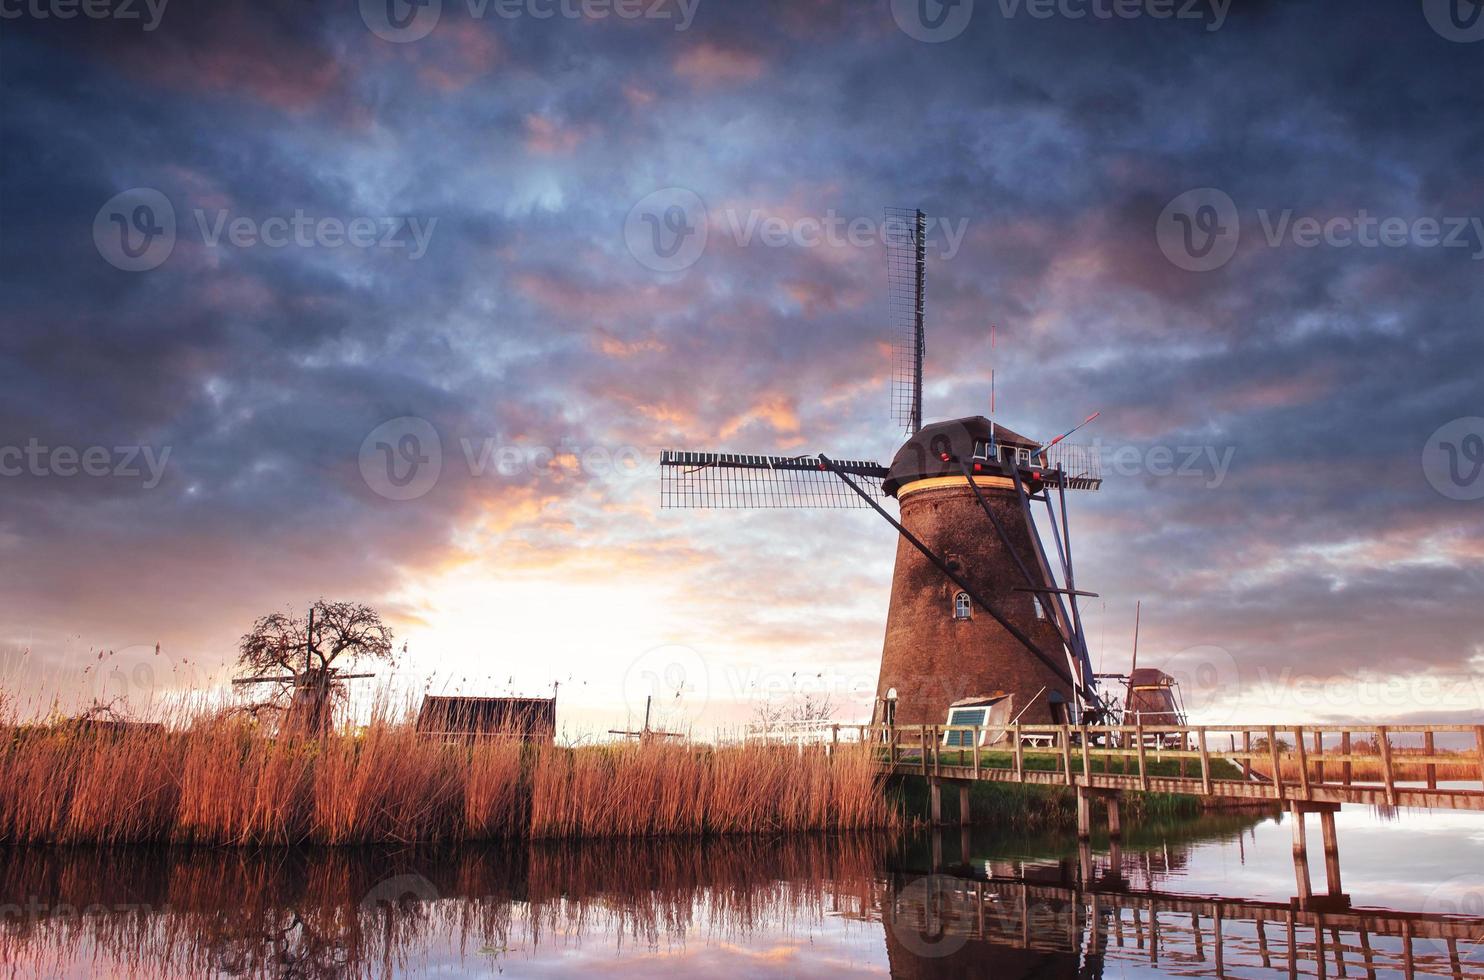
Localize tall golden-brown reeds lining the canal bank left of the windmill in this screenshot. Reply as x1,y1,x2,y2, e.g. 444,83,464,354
0,719,898,845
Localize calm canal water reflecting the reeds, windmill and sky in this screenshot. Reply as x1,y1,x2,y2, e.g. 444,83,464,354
0,808,1484,979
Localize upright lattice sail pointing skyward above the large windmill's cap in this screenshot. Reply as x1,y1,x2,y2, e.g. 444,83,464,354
883,208,928,435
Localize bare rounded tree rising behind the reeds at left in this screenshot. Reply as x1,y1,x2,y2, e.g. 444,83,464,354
237,600,395,734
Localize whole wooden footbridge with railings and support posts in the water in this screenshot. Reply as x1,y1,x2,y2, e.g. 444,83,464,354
830,715,1484,907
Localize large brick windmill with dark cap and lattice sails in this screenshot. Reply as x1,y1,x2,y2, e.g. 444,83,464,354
660,209,1103,725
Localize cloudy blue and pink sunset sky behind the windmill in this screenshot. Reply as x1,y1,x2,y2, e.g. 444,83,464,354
0,0,1484,736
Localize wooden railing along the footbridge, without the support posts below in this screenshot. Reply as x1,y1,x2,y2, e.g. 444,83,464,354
834,725,1484,806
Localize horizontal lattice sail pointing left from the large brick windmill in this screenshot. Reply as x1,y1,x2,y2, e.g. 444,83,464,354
659,450,886,509
